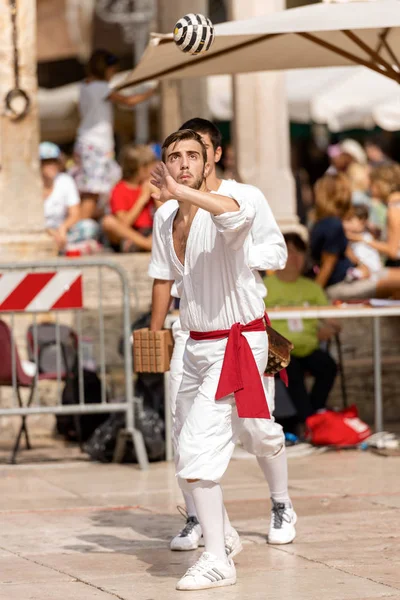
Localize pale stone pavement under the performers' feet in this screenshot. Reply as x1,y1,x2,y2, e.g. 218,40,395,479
0,451,400,600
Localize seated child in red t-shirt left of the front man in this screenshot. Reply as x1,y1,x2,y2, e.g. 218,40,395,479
102,145,156,252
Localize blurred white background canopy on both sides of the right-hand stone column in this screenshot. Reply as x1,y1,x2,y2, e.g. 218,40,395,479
207,67,400,132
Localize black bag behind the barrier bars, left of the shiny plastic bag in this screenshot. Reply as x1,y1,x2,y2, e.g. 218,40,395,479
57,369,109,442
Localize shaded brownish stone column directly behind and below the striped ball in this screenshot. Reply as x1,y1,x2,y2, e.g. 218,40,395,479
158,0,209,139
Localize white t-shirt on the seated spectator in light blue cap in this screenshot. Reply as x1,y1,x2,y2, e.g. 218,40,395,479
44,173,80,229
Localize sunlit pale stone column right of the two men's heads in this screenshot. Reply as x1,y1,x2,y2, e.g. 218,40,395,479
230,0,298,225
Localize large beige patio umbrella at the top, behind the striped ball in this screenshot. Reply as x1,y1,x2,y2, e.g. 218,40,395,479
114,0,400,89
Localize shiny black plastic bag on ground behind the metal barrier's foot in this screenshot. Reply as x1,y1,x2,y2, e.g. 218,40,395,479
84,407,165,463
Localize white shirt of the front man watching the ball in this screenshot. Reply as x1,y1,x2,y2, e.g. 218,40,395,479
160,192,264,331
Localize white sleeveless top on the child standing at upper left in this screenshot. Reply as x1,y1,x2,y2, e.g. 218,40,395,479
77,81,114,152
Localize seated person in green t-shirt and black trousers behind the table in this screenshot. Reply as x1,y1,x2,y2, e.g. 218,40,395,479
265,233,340,433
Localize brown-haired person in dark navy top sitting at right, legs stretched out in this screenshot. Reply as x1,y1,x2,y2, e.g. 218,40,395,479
310,174,400,300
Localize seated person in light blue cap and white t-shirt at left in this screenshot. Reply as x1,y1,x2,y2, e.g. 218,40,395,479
39,142,100,252
